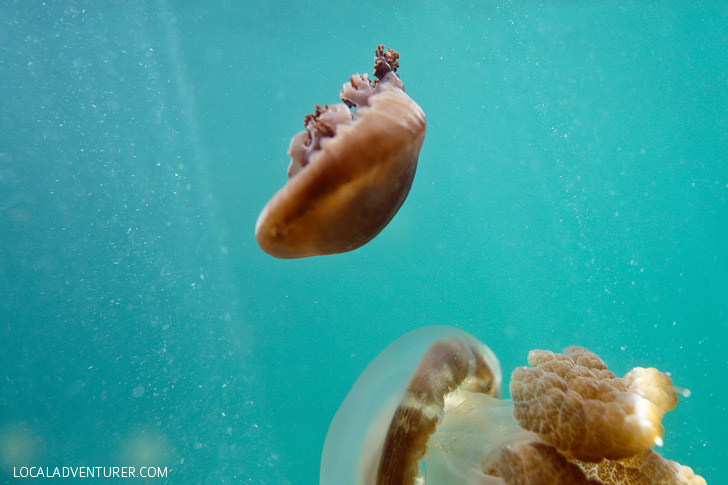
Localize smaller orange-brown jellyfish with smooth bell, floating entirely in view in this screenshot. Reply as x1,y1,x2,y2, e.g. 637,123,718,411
255,45,426,259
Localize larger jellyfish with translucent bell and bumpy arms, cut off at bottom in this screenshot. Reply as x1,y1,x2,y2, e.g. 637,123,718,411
319,326,705,485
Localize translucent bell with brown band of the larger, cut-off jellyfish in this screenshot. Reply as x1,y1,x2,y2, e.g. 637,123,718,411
319,326,527,485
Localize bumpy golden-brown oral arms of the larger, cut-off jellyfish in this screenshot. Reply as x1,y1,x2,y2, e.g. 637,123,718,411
507,347,705,485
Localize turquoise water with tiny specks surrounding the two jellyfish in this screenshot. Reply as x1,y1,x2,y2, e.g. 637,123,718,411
0,0,728,484
